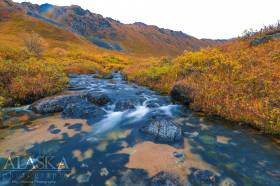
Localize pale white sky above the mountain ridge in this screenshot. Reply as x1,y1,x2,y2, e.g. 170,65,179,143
15,0,280,39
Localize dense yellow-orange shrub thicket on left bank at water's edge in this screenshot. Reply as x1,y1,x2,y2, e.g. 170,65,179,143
0,58,67,103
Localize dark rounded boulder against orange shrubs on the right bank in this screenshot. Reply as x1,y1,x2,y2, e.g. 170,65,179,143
170,84,193,105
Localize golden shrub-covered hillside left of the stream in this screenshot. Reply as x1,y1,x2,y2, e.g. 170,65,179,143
0,1,128,105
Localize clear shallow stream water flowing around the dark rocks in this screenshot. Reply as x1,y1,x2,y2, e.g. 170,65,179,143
0,74,280,186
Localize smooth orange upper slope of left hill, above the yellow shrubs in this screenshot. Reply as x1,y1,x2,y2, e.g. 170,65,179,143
0,0,122,55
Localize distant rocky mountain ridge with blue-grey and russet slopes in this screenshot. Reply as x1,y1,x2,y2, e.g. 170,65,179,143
20,2,223,56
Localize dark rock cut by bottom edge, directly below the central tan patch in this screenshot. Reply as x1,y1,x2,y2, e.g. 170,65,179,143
150,172,183,186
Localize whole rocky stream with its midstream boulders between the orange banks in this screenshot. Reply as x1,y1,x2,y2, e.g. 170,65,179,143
0,73,280,185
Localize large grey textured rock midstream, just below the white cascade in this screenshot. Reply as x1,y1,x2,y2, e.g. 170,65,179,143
140,119,182,142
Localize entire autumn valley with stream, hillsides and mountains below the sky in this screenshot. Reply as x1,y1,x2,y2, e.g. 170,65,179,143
0,0,280,186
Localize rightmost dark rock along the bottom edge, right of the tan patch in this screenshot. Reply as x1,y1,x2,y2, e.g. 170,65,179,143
189,169,219,186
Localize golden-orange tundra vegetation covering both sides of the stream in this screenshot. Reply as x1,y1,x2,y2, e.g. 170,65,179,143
0,8,280,134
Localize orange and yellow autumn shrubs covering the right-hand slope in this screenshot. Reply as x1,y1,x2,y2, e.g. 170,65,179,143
125,29,280,134
